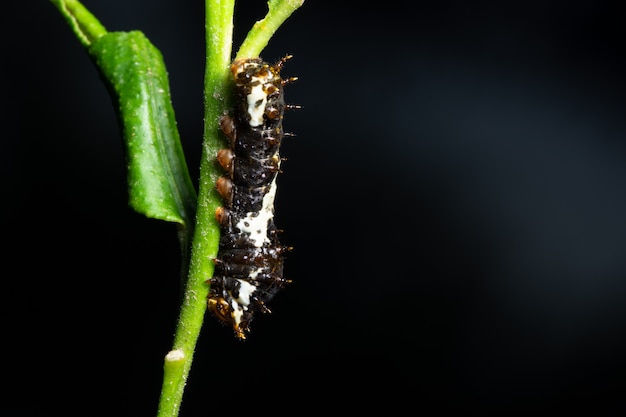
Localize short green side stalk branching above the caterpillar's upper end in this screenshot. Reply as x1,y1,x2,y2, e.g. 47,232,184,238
235,0,304,59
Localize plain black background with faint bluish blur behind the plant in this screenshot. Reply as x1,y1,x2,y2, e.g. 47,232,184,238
0,0,626,417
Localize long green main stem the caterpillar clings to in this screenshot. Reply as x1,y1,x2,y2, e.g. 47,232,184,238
158,0,234,417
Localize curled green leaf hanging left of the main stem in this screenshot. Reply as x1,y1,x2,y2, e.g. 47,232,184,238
88,31,196,225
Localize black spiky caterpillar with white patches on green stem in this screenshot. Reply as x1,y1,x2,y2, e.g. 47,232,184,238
208,55,297,340
